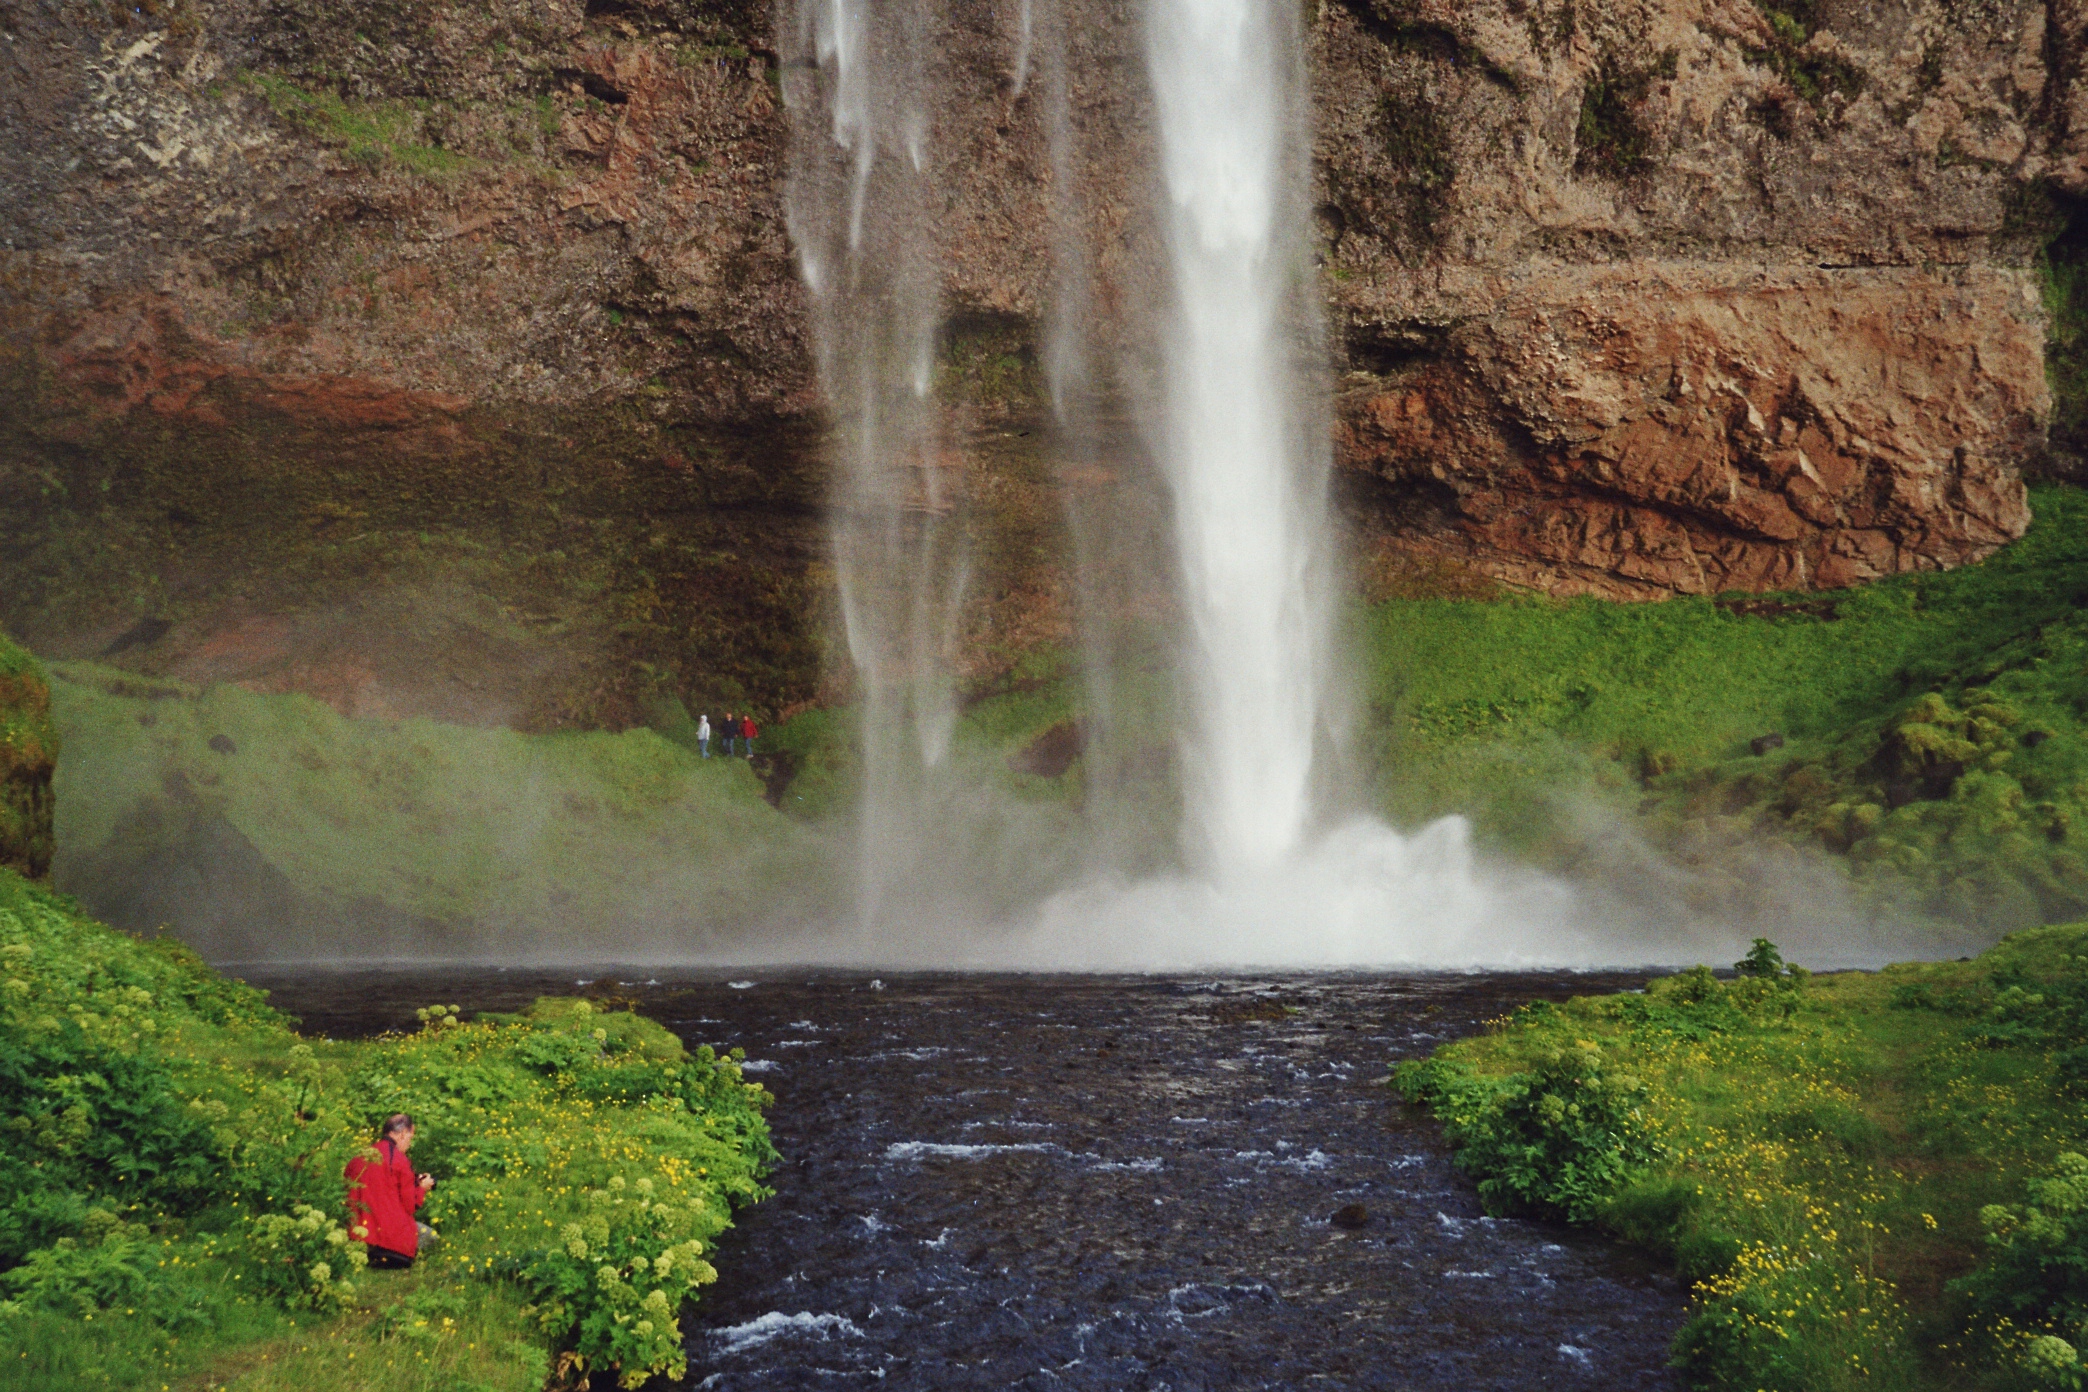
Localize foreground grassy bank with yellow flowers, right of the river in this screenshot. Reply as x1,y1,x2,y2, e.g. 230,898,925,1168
1397,927,2088,1392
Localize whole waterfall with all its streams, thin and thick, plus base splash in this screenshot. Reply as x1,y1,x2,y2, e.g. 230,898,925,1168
783,0,1576,968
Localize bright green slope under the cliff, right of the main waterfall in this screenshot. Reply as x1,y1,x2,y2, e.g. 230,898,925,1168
1361,488,2088,931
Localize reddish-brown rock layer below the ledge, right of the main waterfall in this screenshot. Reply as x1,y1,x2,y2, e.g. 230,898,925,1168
1338,265,2050,597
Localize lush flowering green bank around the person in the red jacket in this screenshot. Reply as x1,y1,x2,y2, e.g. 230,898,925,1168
0,870,773,1392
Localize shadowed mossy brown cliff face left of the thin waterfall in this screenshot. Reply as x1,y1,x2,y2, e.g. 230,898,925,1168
0,0,823,726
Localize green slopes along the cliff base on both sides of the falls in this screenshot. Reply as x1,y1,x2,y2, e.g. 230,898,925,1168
52,486,2088,952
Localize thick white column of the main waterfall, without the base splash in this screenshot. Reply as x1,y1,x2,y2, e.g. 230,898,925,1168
1146,0,1330,877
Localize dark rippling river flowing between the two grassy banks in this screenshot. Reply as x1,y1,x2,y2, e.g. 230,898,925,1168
257,973,1683,1392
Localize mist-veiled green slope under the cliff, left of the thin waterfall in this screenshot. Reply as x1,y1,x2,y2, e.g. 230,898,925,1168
52,664,829,956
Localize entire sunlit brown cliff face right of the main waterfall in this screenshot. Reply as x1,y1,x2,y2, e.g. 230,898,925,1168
1315,0,2062,595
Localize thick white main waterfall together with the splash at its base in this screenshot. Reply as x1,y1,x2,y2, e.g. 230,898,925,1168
1002,0,1570,968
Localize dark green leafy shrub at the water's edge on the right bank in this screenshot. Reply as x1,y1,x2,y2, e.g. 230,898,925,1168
1397,1039,1660,1221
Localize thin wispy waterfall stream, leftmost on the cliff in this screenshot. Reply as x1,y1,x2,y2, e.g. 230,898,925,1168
783,0,969,925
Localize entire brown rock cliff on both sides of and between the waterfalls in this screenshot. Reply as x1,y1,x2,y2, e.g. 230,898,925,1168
0,0,2088,724
